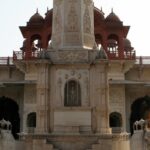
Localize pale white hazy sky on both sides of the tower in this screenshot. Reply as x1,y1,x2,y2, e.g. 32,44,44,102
0,0,150,56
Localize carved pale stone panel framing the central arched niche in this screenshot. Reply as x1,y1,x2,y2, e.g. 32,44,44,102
53,68,89,107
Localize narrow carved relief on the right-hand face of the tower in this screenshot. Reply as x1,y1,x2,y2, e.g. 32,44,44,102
84,6,91,34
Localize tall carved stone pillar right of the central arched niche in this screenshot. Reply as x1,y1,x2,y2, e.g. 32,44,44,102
92,64,111,134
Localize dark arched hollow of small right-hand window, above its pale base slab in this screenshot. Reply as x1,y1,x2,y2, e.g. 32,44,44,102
109,112,122,127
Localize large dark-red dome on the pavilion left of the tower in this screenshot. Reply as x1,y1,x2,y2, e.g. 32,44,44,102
29,11,44,24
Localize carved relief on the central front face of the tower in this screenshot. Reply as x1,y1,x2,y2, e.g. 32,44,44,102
67,1,78,32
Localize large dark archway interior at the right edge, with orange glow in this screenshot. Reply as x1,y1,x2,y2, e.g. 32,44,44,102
130,96,150,134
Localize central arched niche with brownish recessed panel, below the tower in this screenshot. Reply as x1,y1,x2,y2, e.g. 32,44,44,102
64,80,81,106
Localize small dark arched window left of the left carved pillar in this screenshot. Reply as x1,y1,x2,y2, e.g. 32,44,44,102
27,112,36,128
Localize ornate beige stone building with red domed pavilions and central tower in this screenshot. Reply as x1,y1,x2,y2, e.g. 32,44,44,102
0,0,150,150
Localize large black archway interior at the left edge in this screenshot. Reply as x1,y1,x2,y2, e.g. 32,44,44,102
0,96,20,139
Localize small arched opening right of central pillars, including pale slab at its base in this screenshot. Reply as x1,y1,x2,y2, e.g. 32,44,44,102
109,112,122,133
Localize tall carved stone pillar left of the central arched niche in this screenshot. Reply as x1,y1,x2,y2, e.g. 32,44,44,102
36,62,50,133
